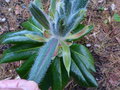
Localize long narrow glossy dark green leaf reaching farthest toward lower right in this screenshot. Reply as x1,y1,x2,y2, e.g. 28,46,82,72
72,50,98,87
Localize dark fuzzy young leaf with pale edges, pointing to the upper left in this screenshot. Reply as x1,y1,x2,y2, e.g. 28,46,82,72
29,3,49,29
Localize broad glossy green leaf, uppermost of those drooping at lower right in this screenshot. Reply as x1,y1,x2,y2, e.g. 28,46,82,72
70,44,95,68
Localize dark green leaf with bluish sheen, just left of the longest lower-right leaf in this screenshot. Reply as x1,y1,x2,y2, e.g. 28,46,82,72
70,60,89,86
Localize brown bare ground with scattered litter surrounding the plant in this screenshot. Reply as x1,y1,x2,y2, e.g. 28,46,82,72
0,0,120,90
